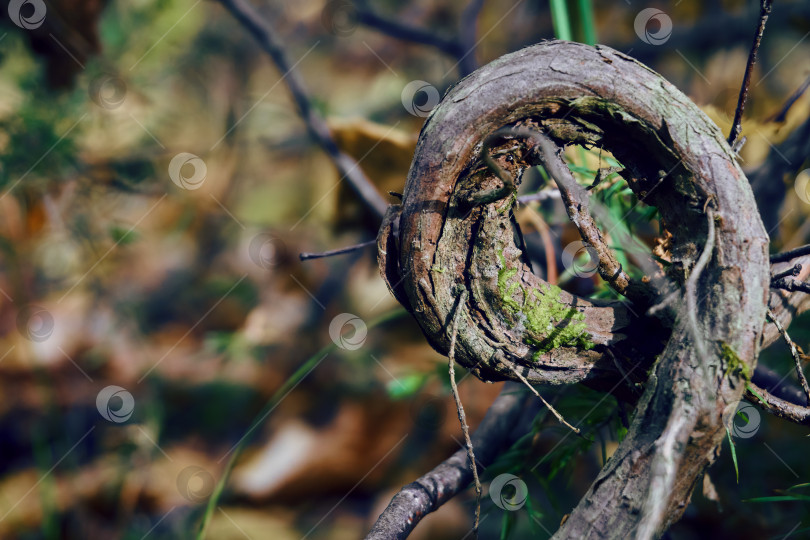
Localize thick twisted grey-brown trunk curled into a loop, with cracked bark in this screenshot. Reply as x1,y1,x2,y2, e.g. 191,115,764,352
378,41,768,538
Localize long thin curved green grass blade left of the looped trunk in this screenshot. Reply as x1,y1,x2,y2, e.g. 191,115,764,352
197,309,408,540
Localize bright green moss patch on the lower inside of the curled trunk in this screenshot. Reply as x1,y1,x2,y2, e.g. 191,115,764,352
498,251,594,360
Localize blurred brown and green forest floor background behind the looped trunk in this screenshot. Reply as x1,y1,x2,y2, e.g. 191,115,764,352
0,0,810,540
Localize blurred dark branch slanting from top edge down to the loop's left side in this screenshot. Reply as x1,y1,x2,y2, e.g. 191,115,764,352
220,0,388,217
